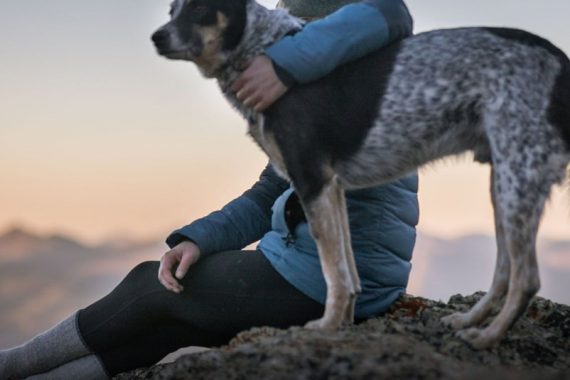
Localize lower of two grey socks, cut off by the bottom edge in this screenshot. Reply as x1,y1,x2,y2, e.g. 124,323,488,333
26,355,110,380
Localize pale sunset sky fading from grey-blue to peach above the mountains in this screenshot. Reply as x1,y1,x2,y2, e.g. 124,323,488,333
0,0,570,242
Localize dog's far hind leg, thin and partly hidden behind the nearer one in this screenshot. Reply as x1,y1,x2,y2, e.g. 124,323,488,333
441,169,510,330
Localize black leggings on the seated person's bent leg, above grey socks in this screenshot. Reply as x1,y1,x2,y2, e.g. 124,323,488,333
79,251,324,376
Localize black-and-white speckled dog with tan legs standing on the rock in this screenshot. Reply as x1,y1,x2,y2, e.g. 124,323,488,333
152,0,570,349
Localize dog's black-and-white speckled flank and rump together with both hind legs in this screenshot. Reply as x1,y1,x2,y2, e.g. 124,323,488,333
348,29,570,348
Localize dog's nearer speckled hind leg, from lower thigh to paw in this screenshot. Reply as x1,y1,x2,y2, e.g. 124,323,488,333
458,162,552,349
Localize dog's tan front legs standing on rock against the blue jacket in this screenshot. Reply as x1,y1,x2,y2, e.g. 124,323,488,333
301,179,357,330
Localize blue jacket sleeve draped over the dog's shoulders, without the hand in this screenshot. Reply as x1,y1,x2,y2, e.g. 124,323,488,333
265,0,413,86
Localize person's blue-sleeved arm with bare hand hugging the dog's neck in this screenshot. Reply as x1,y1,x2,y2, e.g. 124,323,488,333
233,0,413,112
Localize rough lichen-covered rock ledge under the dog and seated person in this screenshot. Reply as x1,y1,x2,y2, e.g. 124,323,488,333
116,293,570,380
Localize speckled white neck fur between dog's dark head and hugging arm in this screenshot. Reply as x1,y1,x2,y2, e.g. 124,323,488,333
215,0,303,124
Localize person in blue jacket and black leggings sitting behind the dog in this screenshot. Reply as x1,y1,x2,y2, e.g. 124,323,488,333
0,0,418,379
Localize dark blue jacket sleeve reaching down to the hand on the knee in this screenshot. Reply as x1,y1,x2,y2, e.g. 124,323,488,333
166,165,289,254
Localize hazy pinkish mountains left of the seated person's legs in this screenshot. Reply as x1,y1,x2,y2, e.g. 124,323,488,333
0,228,167,349
